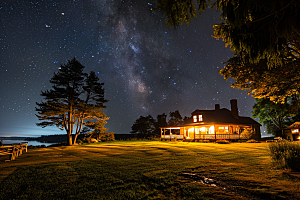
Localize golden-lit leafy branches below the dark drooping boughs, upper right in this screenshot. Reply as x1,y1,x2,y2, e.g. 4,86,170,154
219,52,300,103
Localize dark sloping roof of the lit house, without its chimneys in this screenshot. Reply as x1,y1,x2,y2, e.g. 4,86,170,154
186,108,261,126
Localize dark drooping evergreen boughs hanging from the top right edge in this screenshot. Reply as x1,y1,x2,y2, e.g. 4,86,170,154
157,0,300,65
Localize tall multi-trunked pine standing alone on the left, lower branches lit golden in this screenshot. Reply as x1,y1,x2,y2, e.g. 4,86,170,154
36,58,107,145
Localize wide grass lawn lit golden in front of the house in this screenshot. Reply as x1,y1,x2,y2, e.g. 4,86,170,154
0,141,300,200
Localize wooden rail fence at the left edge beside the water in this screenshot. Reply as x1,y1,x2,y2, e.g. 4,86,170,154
0,142,28,161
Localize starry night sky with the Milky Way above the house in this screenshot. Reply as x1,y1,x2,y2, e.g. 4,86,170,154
0,0,266,136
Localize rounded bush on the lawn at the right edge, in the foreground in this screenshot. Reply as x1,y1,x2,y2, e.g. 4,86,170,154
269,141,300,171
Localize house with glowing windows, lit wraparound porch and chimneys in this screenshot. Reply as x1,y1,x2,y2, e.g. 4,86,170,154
160,99,261,141
